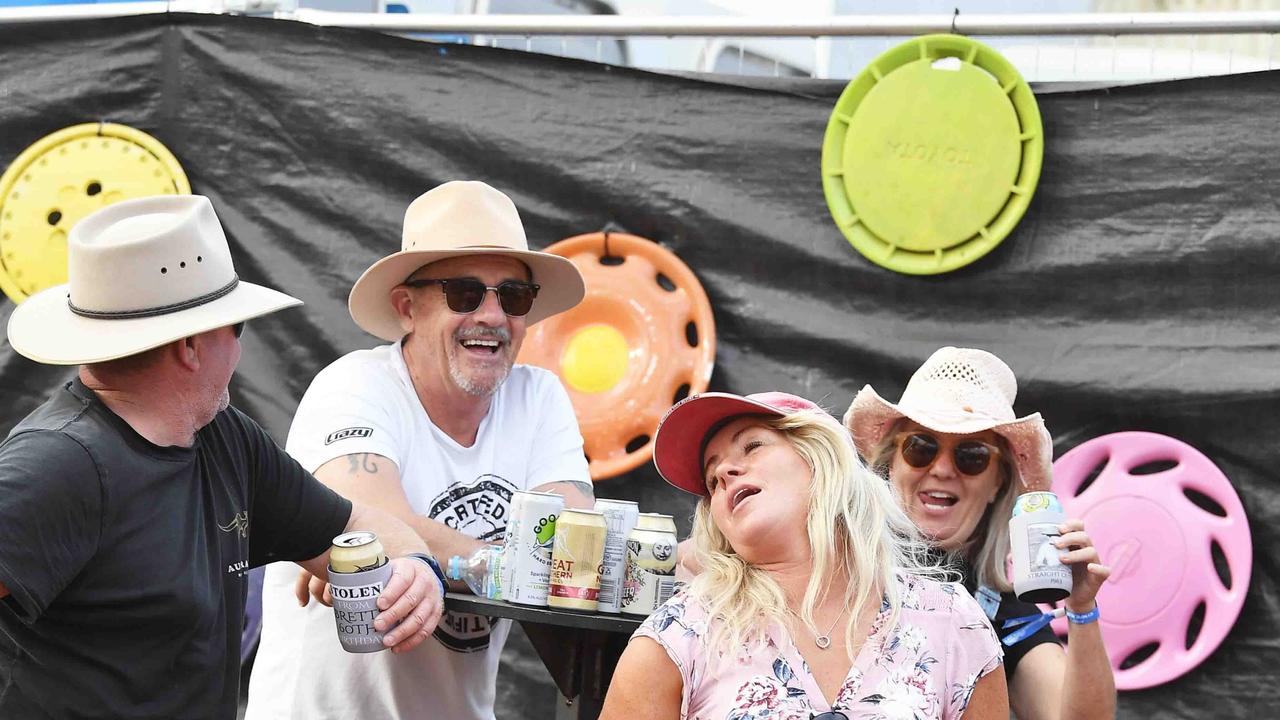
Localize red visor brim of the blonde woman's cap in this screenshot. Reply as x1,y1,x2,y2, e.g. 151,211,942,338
653,392,783,496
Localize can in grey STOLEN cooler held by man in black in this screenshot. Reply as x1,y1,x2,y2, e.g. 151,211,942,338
329,530,392,652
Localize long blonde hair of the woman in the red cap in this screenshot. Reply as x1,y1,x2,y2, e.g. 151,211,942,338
690,410,942,657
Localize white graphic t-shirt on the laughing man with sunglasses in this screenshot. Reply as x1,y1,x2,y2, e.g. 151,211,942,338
246,343,590,720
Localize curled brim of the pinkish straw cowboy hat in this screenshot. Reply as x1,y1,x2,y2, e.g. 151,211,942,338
844,386,1053,489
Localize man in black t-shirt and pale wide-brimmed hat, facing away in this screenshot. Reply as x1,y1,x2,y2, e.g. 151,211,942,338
0,196,442,720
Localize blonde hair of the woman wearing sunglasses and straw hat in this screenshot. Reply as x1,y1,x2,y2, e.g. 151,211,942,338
870,418,1021,592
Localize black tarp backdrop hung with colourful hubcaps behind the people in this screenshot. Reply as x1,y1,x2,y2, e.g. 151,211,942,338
0,15,1280,717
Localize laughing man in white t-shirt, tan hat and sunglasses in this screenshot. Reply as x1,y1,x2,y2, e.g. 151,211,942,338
246,182,591,720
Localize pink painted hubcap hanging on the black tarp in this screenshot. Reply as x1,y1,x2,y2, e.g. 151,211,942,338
1053,432,1253,691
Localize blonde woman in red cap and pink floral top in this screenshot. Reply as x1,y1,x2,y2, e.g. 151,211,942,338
602,392,1009,720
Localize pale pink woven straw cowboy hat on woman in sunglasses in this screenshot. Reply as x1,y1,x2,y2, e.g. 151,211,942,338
845,347,1053,489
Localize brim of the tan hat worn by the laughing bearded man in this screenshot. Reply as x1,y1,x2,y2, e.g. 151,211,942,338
347,247,586,342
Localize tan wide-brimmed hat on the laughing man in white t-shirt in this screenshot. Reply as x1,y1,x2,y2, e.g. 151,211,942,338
347,181,586,342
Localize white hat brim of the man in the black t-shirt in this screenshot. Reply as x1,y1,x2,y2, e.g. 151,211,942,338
9,281,302,365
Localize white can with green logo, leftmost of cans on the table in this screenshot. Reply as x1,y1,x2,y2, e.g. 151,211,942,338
499,491,564,606
